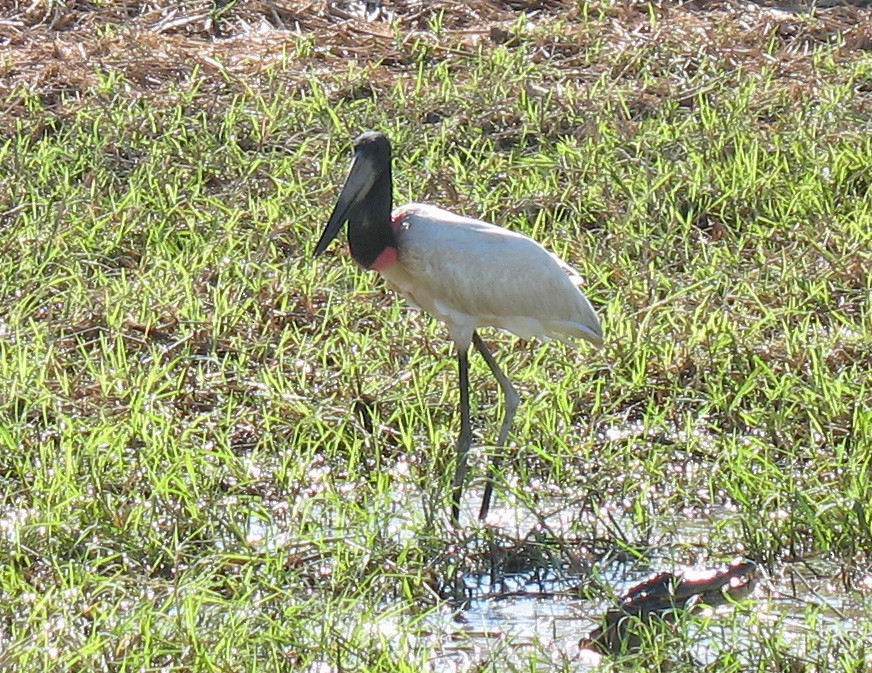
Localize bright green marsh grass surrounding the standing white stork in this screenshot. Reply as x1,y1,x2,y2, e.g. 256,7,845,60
0,2,872,671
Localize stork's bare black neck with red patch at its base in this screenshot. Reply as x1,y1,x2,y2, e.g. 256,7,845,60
348,171,397,271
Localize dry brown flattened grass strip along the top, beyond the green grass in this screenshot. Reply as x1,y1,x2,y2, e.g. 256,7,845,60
0,0,872,123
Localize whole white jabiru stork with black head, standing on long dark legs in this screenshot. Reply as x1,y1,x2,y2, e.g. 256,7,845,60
315,131,603,524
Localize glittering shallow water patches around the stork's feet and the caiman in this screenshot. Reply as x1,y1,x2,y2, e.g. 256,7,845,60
249,489,872,673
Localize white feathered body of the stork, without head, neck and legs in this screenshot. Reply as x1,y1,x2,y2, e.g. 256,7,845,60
379,203,602,349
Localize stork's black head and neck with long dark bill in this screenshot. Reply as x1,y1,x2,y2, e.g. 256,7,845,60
315,131,396,268
